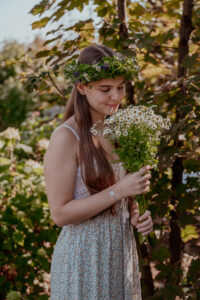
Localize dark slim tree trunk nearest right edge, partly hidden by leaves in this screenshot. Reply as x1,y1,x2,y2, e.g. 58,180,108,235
169,0,193,284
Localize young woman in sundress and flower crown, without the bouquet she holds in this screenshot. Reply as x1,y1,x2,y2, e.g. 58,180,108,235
44,45,153,300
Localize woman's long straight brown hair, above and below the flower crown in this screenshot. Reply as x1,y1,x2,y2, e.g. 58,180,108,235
62,44,119,215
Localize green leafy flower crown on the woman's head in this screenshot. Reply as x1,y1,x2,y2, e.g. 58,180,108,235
64,56,139,83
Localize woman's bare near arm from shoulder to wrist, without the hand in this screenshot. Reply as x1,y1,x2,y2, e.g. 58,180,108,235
44,128,122,226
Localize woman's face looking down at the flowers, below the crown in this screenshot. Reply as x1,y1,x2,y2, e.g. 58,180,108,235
77,76,125,123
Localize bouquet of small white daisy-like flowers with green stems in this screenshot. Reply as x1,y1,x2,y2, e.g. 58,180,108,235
90,105,170,233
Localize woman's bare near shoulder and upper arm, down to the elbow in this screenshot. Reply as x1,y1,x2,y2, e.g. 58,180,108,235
44,117,79,223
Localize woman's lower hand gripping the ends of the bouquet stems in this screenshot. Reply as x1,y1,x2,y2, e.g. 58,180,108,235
130,202,153,236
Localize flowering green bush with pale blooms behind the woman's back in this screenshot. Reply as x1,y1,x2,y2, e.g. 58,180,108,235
0,114,59,300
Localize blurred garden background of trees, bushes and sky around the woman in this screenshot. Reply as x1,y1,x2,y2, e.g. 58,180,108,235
0,0,200,300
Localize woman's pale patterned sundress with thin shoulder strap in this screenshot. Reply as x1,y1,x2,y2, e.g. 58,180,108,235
51,124,142,300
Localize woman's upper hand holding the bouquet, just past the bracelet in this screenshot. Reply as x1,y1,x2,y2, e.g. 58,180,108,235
117,166,152,198
